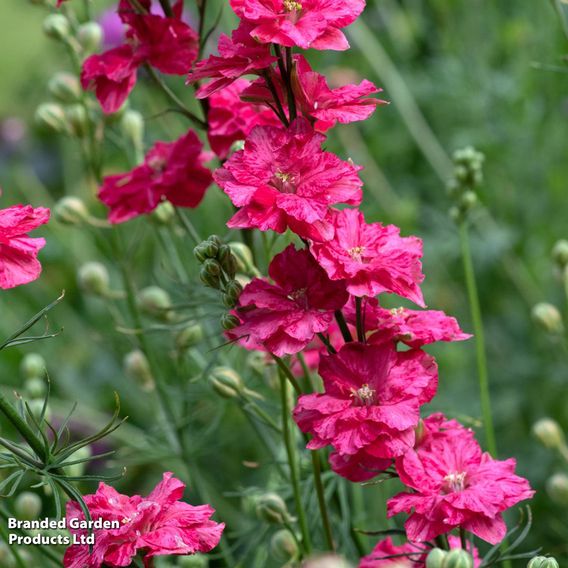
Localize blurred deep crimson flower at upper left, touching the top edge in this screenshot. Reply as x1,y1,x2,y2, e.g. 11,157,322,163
81,0,198,113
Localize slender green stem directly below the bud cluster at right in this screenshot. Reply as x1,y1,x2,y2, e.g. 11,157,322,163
459,222,497,456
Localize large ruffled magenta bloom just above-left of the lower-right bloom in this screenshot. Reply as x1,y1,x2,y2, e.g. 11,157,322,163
294,343,438,460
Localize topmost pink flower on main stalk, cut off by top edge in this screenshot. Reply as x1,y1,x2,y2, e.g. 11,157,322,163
231,0,365,50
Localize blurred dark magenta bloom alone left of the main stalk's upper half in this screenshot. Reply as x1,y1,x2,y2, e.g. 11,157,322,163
99,130,212,223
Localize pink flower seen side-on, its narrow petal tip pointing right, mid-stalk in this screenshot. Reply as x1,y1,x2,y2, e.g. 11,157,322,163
345,298,472,348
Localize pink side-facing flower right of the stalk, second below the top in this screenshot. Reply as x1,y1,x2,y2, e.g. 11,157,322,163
293,55,388,132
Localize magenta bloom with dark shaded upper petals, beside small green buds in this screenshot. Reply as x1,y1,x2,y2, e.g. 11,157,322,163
231,245,348,357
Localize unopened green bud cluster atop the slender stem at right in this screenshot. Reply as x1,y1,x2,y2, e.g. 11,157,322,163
447,146,485,223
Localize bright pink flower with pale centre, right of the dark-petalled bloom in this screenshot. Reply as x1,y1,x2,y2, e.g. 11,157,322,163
311,209,424,306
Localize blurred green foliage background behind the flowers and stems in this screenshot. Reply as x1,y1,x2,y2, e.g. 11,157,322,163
0,0,568,566
